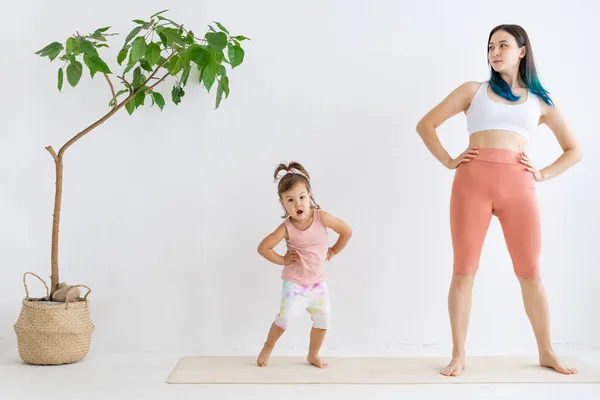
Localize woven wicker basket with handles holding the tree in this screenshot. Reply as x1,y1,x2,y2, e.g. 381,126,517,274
14,272,95,365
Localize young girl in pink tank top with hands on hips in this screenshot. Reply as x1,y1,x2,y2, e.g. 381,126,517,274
256,162,352,368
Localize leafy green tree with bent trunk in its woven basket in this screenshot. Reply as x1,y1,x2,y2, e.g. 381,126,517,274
14,10,249,364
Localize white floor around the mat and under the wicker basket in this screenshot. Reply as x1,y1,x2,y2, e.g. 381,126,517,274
0,340,600,400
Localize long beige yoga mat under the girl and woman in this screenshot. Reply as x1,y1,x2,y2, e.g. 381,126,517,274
167,356,600,384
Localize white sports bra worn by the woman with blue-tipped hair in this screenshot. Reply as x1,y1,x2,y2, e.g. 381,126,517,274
467,82,542,140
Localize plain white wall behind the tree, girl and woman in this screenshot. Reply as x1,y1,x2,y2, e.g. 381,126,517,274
0,0,600,355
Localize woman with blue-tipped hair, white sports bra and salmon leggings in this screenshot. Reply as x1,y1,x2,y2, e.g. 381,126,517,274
417,25,581,376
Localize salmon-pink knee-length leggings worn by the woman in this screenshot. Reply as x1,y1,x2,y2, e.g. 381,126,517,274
450,148,541,278
